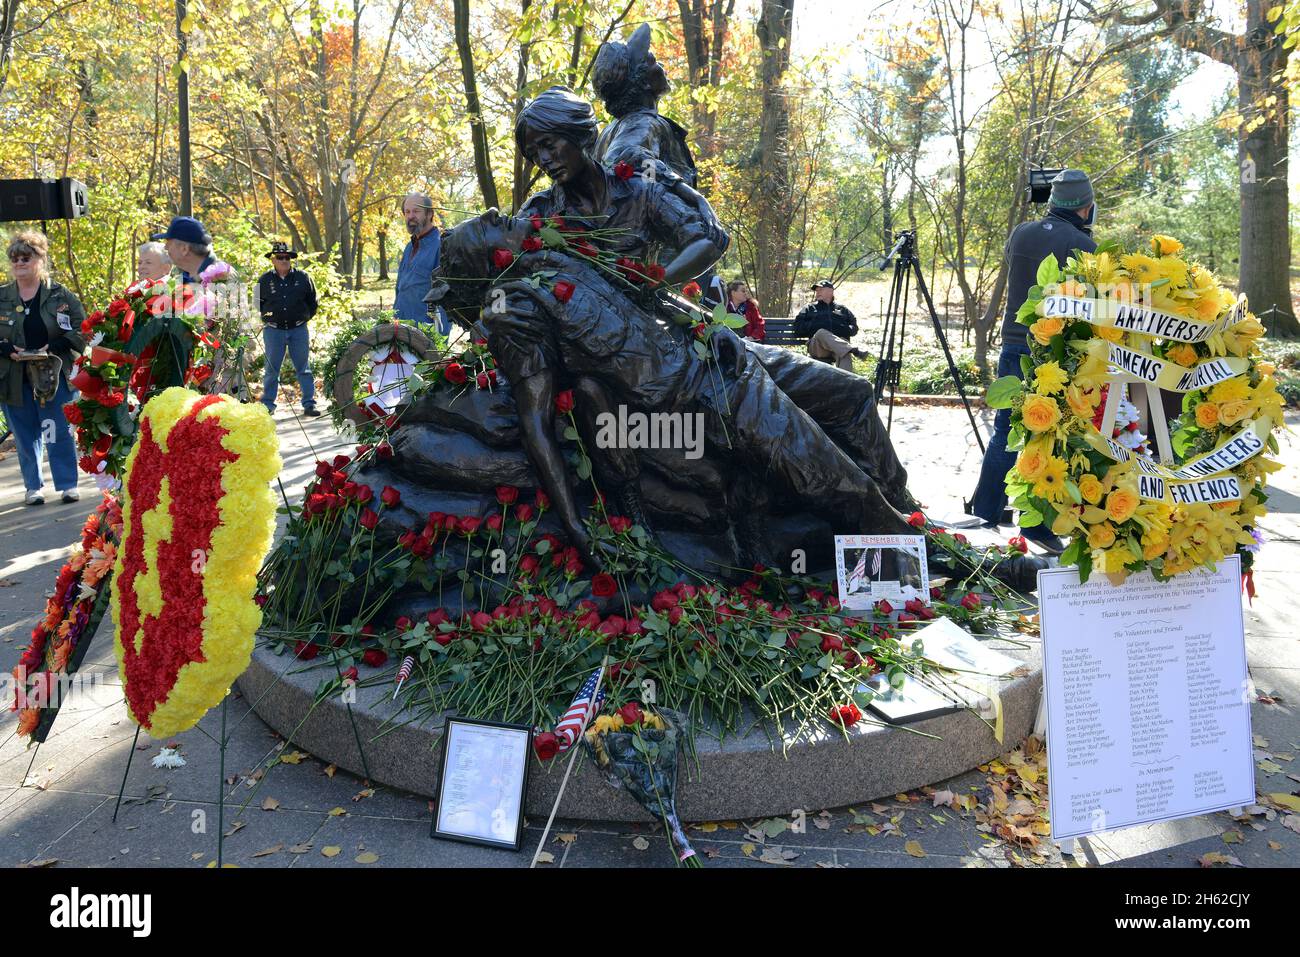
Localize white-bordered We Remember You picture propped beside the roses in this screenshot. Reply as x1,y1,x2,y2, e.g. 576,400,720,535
835,534,930,611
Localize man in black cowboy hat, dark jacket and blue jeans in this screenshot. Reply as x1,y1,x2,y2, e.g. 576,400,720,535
257,243,321,417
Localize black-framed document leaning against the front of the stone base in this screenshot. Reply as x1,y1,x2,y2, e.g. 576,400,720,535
430,718,533,850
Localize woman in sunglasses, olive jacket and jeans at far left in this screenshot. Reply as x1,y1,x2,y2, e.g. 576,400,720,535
0,231,86,505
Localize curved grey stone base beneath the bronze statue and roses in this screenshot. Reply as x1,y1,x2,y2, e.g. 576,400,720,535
239,642,1043,820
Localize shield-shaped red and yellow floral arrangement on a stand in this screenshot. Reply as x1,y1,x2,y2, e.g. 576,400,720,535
112,389,281,737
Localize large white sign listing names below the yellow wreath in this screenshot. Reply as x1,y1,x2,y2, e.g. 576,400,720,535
1039,555,1255,840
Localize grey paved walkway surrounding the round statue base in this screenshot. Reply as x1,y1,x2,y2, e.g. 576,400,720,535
0,395,1300,867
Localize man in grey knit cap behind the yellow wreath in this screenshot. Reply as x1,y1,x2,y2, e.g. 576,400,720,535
967,169,1097,554
